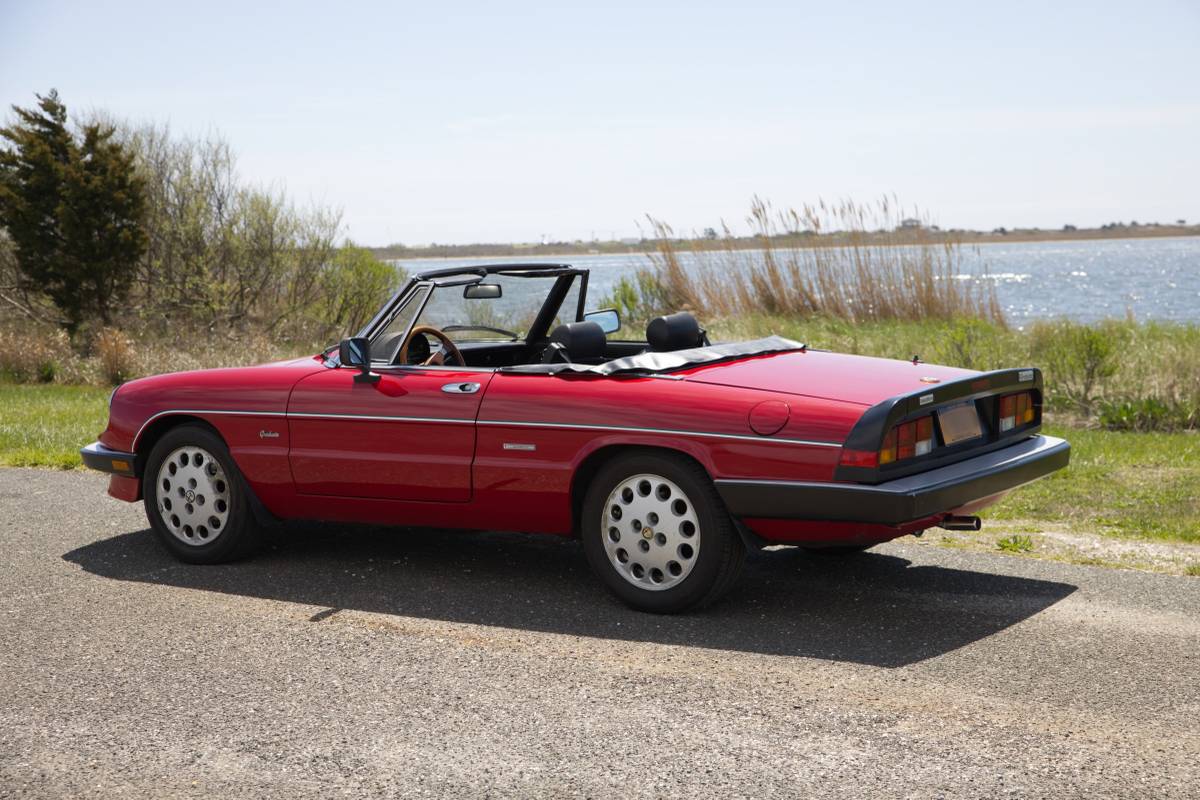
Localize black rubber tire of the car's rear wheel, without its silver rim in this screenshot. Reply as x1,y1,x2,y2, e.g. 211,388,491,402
580,453,740,614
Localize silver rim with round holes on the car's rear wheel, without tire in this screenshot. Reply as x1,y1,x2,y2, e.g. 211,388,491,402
600,473,700,591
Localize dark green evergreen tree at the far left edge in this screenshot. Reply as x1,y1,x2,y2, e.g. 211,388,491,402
0,90,146,332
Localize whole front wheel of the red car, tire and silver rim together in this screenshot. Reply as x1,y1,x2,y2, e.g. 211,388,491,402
142,425,262,564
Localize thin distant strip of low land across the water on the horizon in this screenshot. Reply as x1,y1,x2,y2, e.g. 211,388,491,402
368,224,1200,260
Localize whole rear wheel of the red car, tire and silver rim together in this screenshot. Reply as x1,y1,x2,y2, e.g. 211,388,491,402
581,451,746,614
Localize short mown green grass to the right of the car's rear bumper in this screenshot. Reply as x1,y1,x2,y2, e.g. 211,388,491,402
984,425,1200,542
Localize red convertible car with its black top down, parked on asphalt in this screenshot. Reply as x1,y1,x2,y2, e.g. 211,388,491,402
83,264,1069,612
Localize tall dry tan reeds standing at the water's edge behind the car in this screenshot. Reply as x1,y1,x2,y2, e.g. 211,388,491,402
638,198,1004,325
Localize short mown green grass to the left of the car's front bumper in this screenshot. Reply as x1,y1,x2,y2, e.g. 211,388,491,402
0,384,112,469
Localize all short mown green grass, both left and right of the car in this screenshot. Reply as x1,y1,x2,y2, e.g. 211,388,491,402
0,384,1200,542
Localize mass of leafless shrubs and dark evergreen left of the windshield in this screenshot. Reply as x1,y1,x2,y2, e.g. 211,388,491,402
0,91,400,341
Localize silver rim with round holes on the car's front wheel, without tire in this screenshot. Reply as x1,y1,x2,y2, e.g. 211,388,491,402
155,445,230,547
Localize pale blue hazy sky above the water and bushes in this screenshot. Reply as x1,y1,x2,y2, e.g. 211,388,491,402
0,0,1200,246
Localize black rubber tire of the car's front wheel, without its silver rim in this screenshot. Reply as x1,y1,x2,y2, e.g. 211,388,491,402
142,425,254,564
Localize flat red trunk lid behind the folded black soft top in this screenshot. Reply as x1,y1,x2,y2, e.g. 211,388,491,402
676,350,978,405
